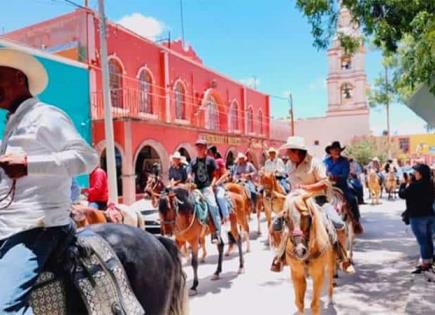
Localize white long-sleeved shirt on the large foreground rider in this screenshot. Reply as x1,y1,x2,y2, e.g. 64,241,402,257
0,98,98,240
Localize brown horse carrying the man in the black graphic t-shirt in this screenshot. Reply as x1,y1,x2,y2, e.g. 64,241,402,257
151,177,244,294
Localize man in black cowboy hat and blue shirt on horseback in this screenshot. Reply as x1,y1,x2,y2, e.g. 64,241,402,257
324,141,362,234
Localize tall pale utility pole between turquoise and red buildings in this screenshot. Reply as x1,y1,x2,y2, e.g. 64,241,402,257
98,0,118,203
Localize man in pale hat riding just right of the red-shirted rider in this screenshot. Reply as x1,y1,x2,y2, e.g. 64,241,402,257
232,152,257,211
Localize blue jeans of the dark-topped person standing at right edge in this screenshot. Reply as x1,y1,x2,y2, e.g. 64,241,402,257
409,215,435,263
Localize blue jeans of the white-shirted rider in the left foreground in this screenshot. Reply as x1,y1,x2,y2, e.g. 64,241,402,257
0,225,70,315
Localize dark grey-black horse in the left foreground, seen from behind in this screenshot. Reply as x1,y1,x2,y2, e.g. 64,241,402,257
68,224,188,315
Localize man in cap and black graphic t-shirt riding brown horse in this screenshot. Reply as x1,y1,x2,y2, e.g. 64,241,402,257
187,139,222,244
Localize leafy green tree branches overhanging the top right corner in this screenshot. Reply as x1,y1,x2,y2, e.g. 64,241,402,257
296,0,435,97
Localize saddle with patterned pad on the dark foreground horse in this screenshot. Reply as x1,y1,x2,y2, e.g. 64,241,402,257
30,228,145,315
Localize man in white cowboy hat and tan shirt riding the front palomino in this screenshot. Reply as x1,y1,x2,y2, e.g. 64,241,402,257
272,137,353,272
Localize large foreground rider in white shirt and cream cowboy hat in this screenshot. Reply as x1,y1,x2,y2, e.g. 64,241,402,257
0,48,98,314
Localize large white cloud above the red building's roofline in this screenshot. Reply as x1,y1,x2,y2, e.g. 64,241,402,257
118,12,166,40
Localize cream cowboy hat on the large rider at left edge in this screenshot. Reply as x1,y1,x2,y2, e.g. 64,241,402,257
0,48,48,96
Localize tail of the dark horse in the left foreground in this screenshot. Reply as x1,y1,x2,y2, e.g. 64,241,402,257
158,236,189,315
